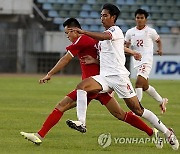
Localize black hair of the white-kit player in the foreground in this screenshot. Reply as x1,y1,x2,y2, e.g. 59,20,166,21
101,3,120,22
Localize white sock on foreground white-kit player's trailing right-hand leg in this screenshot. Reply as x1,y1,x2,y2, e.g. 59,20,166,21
142,109,168,134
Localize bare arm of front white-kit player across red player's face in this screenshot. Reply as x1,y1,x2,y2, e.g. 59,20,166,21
69,28,111,41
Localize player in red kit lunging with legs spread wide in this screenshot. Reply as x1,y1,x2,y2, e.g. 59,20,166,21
21,18,159,145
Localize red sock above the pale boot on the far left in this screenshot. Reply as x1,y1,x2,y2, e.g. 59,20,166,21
38,108,63,138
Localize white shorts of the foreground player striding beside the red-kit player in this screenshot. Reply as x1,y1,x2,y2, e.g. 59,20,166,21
92,75,136,98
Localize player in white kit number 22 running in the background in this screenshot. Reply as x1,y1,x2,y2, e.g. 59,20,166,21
125,9,168,113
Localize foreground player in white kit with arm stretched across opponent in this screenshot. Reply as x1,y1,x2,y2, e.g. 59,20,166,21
67,4,179,150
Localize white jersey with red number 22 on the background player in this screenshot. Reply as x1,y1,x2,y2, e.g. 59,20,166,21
125,26,159,67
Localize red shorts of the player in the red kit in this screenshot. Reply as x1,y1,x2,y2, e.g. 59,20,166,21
67,89,112,105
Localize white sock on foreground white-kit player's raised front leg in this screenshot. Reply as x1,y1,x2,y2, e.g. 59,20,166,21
76,90,87,125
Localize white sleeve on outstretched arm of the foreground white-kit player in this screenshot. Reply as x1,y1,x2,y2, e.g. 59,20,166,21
105,26,124,40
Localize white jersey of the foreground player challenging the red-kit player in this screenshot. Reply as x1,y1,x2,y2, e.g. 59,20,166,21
98,26,130,76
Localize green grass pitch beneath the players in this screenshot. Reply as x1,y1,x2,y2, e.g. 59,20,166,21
0,74,180,154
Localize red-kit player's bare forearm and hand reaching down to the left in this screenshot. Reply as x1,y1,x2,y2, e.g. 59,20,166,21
39,52,73,83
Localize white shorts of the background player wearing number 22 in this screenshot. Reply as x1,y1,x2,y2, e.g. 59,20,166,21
135,64,152,80
